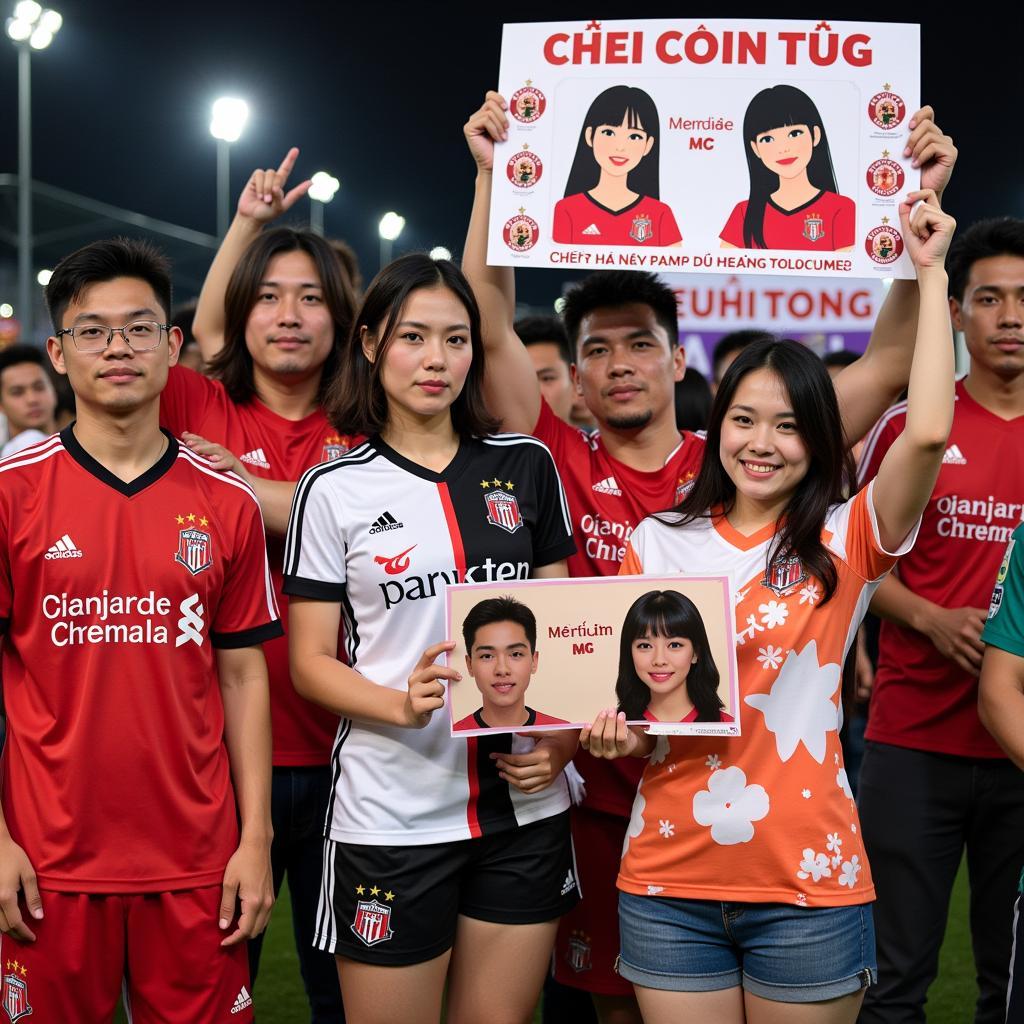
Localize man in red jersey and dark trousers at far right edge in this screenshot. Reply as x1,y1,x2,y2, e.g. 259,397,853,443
858,217,1024,1024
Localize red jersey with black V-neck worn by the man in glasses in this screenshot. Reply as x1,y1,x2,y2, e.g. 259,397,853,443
0,427,281,893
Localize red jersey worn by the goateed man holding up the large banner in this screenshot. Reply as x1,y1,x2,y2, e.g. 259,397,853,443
534,401,705,817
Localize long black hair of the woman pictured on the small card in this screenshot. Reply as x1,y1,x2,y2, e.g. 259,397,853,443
615,590,724,722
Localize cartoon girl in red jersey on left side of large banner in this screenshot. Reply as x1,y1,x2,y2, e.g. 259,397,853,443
552,85,683,247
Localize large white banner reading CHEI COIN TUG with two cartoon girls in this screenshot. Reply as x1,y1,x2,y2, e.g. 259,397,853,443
488,19,921,278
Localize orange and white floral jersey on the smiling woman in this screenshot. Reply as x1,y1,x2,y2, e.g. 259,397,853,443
618,484,913,906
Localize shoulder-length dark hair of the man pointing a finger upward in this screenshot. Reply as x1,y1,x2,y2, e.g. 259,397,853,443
207,227,355,404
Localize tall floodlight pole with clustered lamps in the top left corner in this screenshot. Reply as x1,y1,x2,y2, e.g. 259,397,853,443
7,0,63,341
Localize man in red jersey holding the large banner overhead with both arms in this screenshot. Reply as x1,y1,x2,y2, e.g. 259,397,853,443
463,92,956,1024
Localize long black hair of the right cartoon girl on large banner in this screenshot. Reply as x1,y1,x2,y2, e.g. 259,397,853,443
743,85,839,249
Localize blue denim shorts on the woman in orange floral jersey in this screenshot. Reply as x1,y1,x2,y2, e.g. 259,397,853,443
618,892,878,1002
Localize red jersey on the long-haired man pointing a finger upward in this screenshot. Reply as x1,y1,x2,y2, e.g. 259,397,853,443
160,367,354,766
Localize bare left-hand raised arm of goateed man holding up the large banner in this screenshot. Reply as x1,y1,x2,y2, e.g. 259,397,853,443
462,92,541,433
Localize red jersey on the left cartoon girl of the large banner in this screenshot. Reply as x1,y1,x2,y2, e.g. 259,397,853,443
551,193,683,246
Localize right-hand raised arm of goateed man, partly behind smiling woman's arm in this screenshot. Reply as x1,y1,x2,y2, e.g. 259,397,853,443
836,106,956,445
